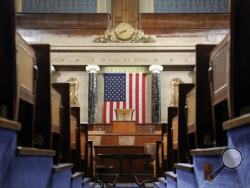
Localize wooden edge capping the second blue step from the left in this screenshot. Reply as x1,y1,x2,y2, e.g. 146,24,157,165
17,146,56,157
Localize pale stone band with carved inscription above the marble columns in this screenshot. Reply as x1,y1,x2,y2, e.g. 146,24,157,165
51,51,195,65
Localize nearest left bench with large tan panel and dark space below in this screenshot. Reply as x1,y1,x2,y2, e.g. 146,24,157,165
13,34,38,147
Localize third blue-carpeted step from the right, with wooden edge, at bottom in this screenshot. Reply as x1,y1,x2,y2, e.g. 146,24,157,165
174,163,198,188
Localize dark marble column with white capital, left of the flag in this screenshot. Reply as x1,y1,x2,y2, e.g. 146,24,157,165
86,65,100,123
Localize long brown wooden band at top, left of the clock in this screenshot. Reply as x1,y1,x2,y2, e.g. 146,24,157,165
16,13,110,29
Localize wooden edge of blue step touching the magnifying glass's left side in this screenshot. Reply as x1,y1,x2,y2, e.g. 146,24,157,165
190,147,226,156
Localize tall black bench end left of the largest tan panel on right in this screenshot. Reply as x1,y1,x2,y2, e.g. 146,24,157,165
195,45,215,148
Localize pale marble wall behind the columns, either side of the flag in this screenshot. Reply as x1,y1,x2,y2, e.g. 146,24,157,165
52,68,193,123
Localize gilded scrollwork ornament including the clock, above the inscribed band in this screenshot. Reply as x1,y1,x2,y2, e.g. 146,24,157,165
94,22,156,43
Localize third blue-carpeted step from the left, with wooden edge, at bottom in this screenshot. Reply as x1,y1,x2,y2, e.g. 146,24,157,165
52,163,73,188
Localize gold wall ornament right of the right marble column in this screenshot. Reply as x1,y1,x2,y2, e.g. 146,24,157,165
169,78,183,106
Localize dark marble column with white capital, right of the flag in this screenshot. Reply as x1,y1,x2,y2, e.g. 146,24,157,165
149,65,163,123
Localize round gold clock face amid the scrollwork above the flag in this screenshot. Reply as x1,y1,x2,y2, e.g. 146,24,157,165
115,23,134,41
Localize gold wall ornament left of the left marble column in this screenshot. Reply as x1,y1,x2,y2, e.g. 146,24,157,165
67,77,80,106
